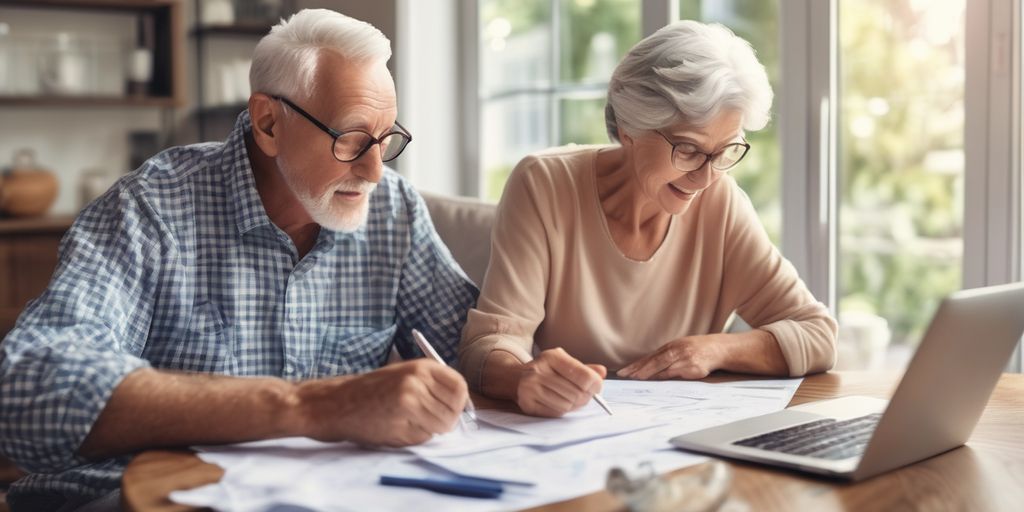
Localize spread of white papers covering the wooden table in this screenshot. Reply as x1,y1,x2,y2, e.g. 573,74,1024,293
171,379,801,512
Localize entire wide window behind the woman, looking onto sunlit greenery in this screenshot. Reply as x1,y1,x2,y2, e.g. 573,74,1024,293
468,0,1024,369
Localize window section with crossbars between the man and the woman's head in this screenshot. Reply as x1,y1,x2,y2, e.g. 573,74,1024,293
478,0,640,201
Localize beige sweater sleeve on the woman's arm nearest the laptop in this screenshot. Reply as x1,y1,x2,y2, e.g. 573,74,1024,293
722,182,838,377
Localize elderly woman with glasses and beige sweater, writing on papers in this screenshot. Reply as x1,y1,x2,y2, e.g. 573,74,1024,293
460,22,837,416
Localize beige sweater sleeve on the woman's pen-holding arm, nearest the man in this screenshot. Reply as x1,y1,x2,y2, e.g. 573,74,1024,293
459,157,551,391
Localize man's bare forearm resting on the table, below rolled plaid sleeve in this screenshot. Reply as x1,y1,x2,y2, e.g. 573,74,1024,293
79,369,304,459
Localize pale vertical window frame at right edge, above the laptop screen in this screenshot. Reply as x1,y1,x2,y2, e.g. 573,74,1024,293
963,0,1024,372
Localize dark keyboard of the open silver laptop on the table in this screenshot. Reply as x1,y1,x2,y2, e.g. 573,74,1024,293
733,413,882,461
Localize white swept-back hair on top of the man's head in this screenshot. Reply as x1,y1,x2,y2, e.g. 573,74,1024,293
249,9,391,101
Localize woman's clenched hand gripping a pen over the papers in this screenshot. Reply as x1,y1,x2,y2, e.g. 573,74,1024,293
516,348,607,418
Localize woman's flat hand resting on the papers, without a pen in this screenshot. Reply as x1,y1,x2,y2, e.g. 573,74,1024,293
615,335,721,380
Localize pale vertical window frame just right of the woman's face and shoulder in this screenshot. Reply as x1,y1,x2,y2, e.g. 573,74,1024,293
776,0,839,315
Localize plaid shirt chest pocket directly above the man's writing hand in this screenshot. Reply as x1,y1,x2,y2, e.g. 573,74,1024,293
316,324,398,377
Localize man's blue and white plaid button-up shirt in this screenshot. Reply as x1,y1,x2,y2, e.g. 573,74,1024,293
0,113,477,510
